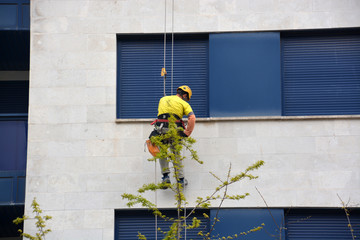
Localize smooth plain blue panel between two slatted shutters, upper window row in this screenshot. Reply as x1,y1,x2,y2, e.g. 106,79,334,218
209,32,281,117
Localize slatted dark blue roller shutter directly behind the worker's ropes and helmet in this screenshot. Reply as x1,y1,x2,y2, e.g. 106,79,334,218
117,35,209,118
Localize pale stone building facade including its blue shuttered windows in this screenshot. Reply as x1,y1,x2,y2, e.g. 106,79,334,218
0,0,360,240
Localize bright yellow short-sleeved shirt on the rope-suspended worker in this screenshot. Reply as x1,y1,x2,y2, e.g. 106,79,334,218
158,95,193,119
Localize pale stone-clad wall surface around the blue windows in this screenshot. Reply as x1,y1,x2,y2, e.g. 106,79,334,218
25,0,360,240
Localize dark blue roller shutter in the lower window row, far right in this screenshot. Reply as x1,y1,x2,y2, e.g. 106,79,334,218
286,209,360,240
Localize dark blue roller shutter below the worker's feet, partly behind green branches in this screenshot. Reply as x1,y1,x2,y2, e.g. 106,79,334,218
115,210,209,240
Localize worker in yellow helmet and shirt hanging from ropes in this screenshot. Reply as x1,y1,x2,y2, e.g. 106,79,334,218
149,85,196,188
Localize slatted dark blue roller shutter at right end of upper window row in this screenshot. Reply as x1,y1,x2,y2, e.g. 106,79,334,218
281,33,360,116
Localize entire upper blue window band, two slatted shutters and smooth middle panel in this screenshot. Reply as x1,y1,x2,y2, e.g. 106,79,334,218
117,29,360,118
